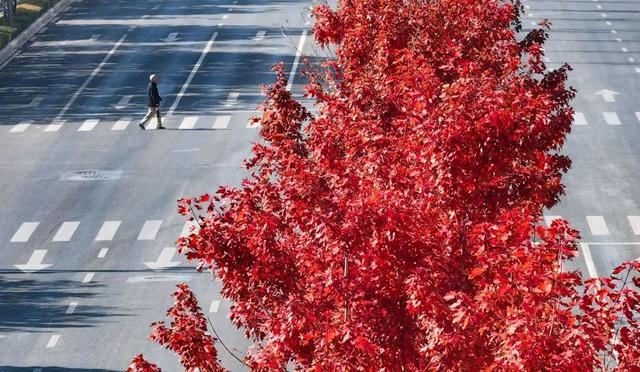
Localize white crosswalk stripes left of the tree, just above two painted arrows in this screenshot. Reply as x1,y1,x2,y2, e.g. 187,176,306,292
9,220,198,243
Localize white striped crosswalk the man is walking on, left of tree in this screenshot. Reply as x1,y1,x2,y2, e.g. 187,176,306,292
7,115,257,135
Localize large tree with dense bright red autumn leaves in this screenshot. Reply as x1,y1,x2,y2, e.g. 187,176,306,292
132,0,640,370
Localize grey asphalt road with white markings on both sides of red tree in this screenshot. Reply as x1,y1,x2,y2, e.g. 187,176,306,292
0,0,640,371
